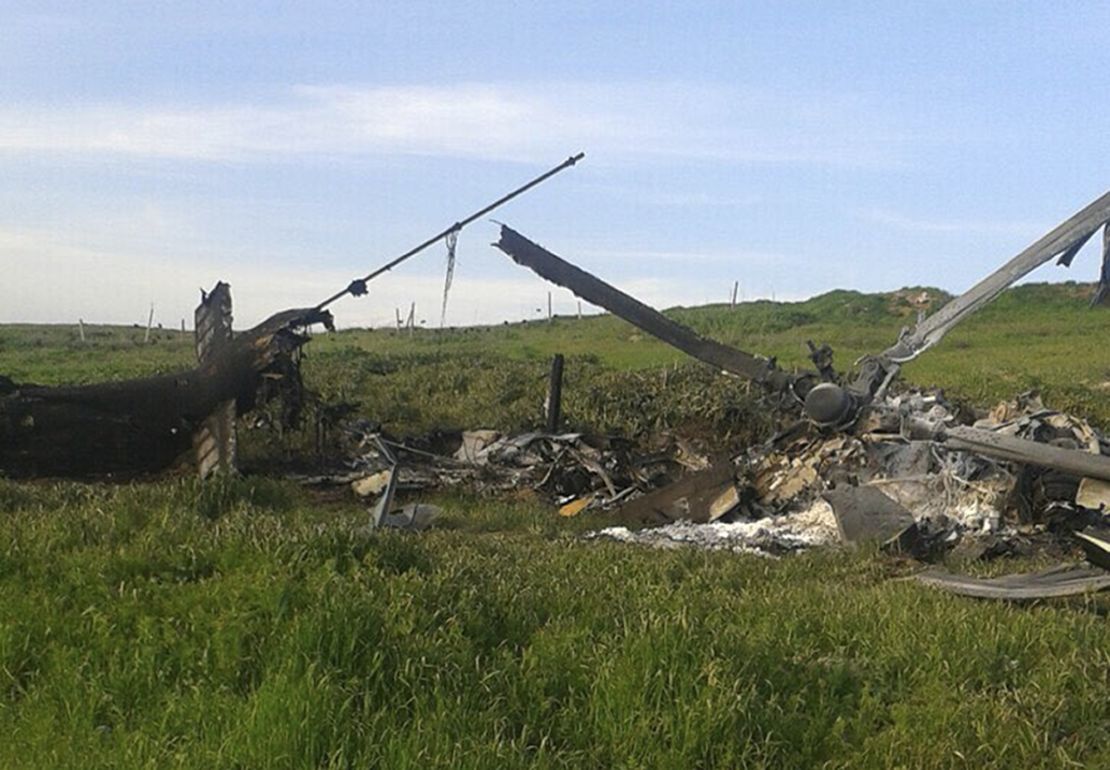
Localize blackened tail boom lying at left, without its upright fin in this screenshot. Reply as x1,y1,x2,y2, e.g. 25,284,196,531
0,286,332,477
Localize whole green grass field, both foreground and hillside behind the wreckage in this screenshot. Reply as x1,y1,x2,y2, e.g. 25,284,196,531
0,285,1110,768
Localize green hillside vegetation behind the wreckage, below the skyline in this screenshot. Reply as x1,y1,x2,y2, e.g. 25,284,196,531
0,283,1110,434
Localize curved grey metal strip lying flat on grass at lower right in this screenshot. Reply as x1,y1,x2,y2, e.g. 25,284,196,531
914,565,1110,601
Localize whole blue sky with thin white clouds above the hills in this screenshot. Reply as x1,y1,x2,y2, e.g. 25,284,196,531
0,0,1110,325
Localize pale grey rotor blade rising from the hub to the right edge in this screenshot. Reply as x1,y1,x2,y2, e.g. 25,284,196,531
882,193,1110,364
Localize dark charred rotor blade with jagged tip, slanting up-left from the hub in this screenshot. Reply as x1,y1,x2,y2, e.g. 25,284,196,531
494,225,793,391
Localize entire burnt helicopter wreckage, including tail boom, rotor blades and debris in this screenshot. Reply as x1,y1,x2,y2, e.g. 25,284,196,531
0,168,1110,599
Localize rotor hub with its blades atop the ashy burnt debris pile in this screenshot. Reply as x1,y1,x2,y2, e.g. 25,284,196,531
494,193,1110,599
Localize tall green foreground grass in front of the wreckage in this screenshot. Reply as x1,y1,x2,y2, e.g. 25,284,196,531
0,479,1110,768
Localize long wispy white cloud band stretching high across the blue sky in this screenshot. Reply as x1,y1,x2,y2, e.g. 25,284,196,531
0,83,905,166
